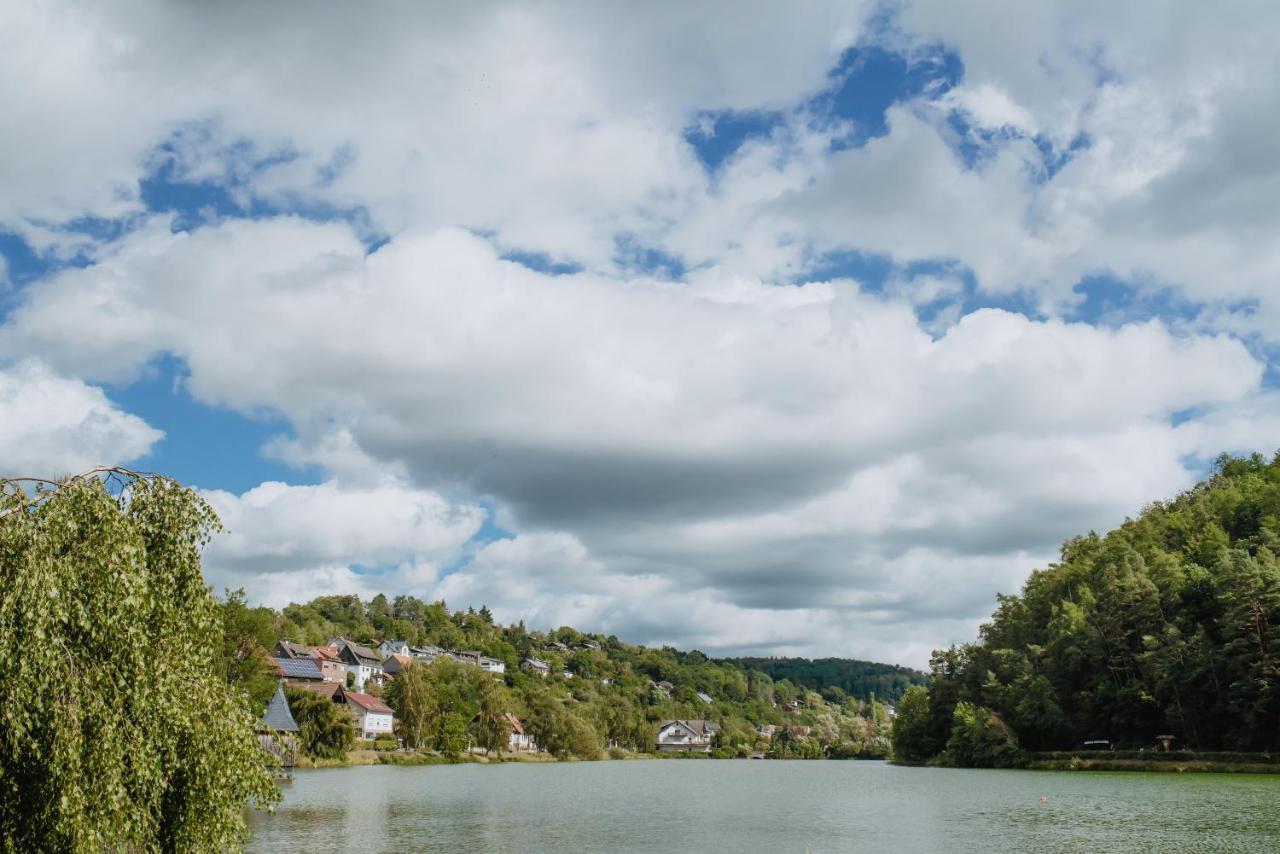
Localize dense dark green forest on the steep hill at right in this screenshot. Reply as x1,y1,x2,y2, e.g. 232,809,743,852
895,455,1280,764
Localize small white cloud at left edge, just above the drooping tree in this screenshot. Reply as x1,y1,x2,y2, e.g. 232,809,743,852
0,360,164,478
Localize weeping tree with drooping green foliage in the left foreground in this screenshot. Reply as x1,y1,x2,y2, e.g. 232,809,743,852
0,469,279,851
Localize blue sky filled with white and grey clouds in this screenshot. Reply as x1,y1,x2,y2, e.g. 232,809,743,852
0,0,1280,666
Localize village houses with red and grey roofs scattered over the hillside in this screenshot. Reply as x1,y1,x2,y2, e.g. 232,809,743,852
260,638,732,767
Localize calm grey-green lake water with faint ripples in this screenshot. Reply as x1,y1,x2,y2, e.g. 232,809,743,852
250,761,1280,854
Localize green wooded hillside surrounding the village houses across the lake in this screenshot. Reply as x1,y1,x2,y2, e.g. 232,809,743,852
220,592,891,758
